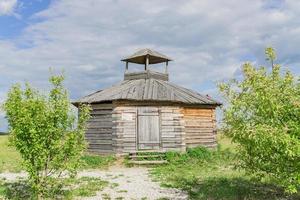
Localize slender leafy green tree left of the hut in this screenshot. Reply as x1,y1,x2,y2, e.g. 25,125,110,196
4,76,90,197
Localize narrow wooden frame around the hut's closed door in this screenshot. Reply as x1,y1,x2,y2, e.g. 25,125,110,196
135,106,162,151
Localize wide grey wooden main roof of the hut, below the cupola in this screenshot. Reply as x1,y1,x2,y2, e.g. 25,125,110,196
75,78,220,105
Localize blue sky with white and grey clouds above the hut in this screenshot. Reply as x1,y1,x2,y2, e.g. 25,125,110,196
0,0,300,131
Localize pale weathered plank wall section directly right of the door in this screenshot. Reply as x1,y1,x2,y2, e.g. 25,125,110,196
160,106,186,151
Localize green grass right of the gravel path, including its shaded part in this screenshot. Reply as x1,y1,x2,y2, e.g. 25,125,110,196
151,136,300,200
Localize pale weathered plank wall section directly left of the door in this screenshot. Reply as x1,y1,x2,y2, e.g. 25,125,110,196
112,106,137,154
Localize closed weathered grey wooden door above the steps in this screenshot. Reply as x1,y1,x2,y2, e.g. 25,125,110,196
138,107,160,149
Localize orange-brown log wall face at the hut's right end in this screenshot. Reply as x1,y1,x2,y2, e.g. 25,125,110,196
183,108,217,148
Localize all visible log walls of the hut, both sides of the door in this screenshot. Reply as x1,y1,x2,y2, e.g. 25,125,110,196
85,104,217,154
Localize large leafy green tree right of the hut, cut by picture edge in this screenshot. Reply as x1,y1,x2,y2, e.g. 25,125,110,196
219,48,300,192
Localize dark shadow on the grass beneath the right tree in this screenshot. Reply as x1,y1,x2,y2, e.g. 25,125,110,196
179,178,300,200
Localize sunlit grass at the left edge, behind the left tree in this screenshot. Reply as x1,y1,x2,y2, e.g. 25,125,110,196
0,135,22,172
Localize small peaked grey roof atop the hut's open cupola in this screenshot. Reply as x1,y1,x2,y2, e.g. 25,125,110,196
122,49,172,64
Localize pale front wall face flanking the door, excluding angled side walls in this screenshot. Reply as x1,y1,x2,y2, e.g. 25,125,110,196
112,105,186,154
